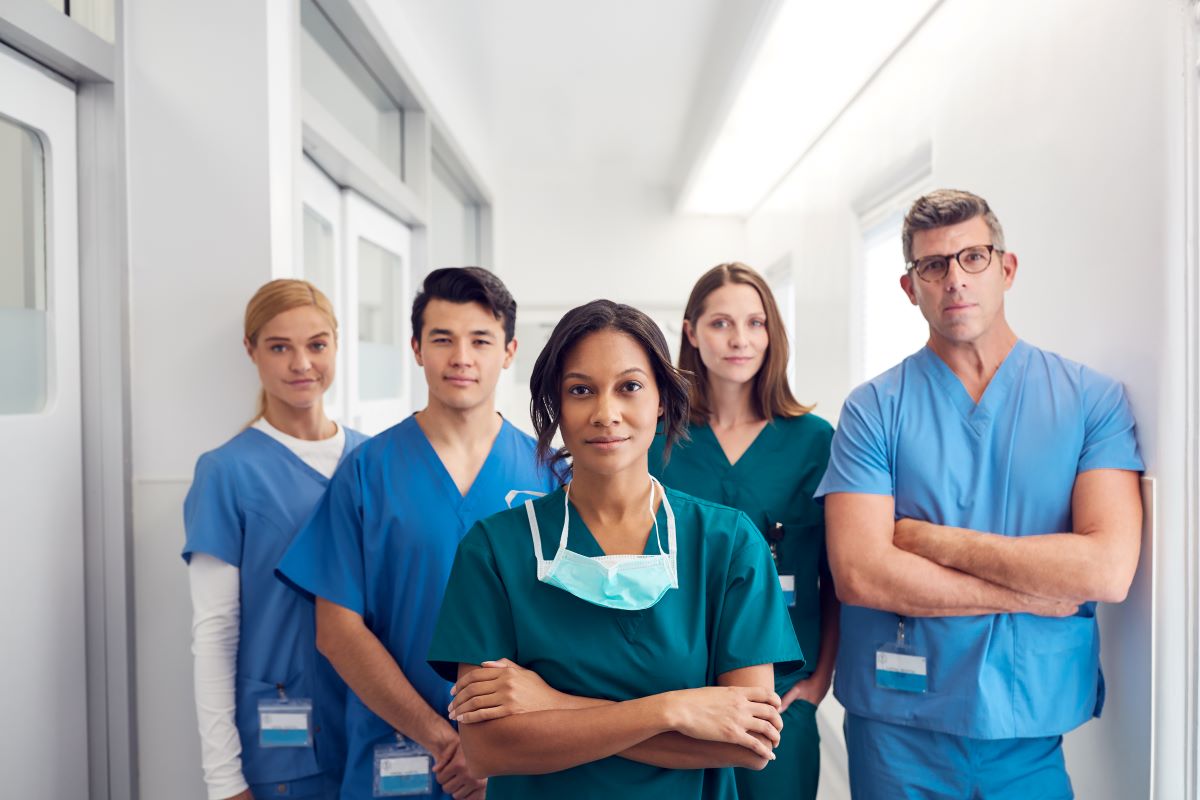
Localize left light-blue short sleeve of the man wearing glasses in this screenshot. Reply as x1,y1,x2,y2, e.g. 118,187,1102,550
815,384,893,501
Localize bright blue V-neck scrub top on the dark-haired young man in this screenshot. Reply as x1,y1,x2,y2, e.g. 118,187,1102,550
278,416,557,798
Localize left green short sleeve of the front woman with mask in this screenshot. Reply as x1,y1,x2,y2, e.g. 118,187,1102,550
428,523,517,681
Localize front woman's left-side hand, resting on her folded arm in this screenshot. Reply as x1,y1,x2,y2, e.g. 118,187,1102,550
450,658,571,723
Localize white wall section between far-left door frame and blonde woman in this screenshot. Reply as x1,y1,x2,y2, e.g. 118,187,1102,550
125,0,299,800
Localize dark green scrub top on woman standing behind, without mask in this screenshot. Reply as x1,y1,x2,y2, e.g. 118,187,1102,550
650,414,833,694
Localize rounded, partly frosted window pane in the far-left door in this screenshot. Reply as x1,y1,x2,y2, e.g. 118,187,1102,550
0,118,48,414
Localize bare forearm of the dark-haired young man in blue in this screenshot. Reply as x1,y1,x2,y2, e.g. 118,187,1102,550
317,599,456,752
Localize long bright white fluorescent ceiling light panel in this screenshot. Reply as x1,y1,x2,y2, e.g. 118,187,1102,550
680,0,938,216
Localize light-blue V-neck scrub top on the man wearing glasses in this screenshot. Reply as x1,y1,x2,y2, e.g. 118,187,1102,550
817,341,1144,739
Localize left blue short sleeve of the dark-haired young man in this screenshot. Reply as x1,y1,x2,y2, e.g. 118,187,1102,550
276,458,366,616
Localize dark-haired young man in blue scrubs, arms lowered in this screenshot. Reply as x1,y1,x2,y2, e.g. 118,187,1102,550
280,267,557,800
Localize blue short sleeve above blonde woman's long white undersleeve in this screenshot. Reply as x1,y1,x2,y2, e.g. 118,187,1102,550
182,453,246,567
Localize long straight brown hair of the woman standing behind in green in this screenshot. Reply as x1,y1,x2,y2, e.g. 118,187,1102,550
679,261,812,425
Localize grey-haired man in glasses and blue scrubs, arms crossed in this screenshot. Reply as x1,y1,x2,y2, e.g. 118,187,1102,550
817,190,1142,800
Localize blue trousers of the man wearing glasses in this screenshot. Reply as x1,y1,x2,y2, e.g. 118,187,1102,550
846,714,1075,800
